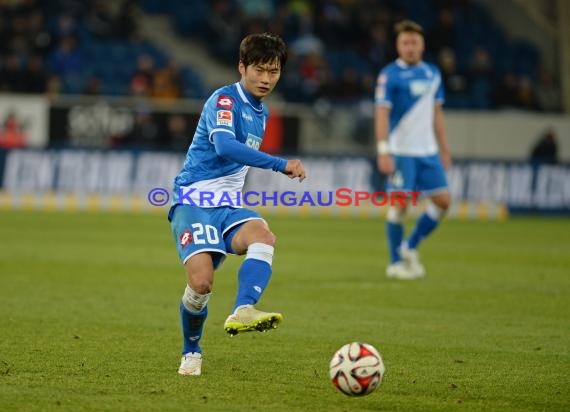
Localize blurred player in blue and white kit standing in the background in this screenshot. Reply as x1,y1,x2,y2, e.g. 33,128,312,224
375,20,451,279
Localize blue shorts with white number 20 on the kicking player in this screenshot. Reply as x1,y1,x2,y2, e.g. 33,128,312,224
170,205,262,268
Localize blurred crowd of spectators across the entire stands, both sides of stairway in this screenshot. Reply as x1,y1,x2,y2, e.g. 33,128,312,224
0,0,561,111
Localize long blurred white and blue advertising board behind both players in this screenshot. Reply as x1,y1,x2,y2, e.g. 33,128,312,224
0,150,570,214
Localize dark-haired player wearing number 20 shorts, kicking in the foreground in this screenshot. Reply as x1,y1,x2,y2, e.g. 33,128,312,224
168,33,305,375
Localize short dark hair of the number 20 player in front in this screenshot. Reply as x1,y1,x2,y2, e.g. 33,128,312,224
239,33,287,69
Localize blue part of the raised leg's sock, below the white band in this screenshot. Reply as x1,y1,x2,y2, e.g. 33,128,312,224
233,258,271,310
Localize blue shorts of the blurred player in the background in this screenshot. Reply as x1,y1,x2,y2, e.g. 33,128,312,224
388,154,447,196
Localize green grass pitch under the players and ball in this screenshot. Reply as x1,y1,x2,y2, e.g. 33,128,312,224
0,211,570,412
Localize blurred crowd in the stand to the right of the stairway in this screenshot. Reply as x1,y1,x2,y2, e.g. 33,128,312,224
155,0,560,111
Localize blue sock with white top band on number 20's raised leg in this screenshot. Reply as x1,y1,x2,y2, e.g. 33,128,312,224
232,243,274,312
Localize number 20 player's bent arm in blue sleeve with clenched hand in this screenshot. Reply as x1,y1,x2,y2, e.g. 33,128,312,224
210,129,306,181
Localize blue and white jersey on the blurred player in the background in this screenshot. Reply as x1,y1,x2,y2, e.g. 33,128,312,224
375,59,444,156
